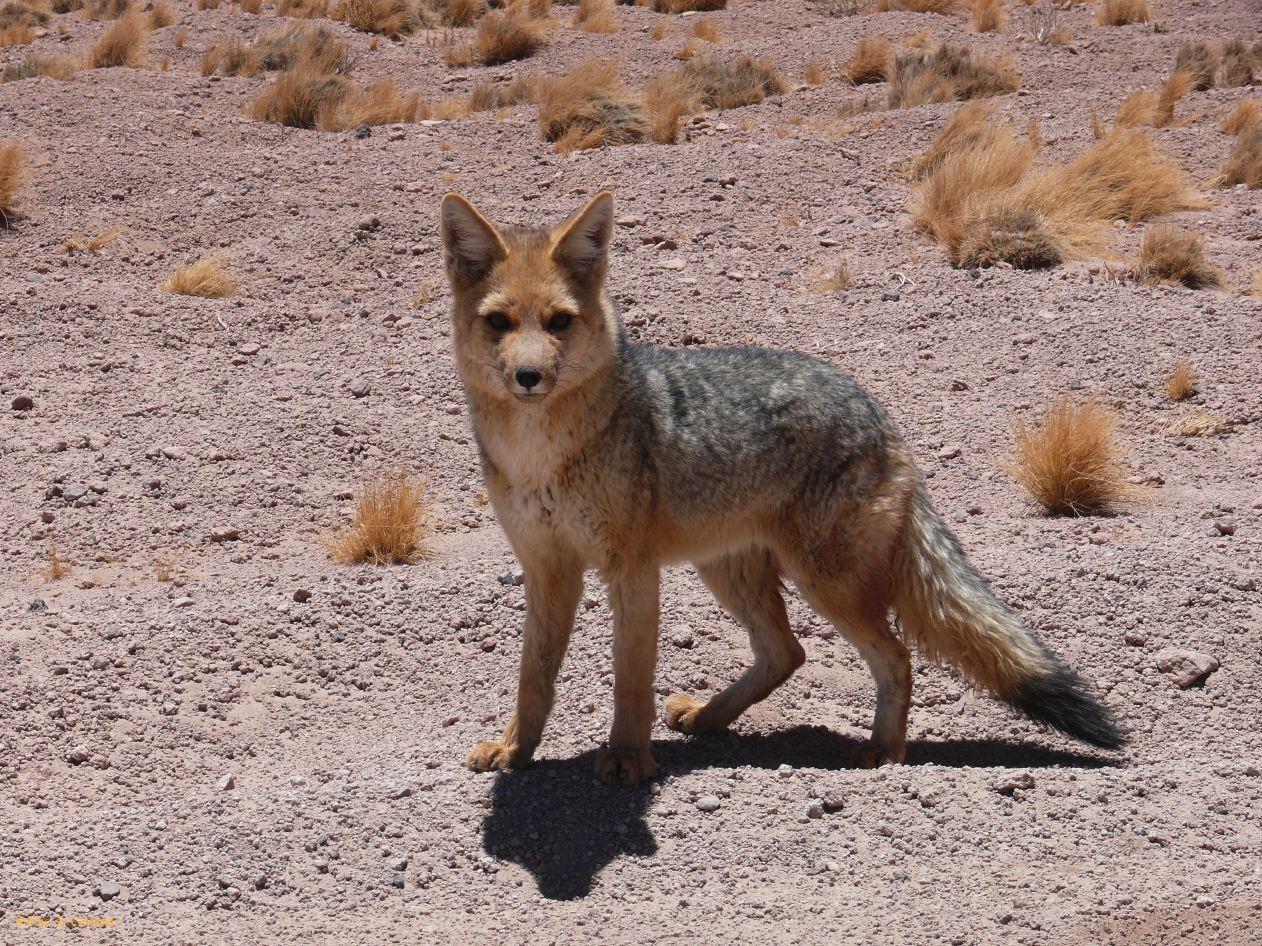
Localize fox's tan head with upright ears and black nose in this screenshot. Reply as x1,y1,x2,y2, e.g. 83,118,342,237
440,190,618,401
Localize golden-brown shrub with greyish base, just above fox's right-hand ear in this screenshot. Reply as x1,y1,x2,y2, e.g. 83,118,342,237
539,59,649,153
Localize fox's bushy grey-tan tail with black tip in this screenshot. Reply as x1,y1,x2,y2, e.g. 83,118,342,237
895,486,1126,749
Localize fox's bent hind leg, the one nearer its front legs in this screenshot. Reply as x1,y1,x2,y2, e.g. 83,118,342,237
666,549,806,733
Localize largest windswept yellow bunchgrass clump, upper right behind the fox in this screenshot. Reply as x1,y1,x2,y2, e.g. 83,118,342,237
911,106,1205,269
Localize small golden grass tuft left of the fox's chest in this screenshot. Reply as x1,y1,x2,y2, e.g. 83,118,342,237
324,470,434,565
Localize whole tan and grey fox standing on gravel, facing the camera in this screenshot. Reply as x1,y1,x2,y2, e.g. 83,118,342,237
439,190,1127,785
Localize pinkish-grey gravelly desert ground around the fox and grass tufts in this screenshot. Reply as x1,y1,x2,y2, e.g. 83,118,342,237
0,0,1262,946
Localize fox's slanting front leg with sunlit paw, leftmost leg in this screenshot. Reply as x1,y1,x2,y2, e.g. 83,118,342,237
467,556,583,772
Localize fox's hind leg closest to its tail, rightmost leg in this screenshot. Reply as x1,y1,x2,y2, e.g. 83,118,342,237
796,580,911,768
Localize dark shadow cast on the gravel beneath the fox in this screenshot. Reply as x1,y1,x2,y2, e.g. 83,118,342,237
482,725,1117,901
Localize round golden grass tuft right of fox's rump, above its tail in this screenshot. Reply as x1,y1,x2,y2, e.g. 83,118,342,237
1003,397,1138,516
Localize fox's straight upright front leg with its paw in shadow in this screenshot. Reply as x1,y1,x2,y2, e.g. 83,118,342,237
596,565,659,785
